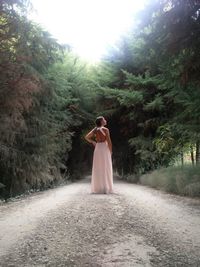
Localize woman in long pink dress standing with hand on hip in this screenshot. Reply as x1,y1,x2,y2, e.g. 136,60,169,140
85,116,113,194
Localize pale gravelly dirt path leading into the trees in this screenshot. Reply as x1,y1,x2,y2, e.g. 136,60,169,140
0,179,200,267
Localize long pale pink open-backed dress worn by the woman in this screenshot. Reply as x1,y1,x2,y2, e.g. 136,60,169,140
91,127,113,194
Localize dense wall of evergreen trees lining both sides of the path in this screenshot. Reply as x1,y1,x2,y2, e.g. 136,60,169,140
0,0,200,197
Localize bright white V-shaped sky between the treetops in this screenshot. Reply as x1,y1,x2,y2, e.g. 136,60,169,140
30,0,145,62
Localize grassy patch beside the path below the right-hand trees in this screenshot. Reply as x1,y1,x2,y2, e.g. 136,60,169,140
140,165,200,197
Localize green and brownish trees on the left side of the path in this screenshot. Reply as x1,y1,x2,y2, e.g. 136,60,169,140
0,0,94,197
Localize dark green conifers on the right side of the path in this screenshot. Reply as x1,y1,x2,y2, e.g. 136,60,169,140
92,0,200,180
